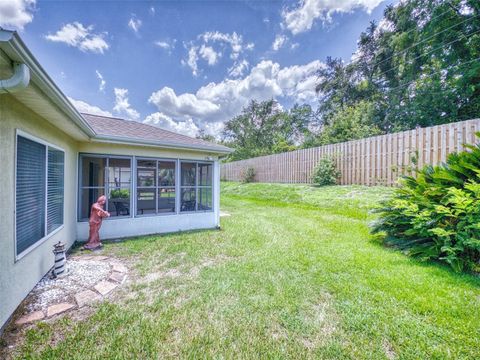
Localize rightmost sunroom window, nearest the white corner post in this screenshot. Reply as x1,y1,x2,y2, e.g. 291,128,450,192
180,162,213,212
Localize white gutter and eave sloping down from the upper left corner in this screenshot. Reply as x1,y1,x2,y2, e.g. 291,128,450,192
0,28,95,137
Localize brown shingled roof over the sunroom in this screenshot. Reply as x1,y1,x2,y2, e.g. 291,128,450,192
82,113,232,153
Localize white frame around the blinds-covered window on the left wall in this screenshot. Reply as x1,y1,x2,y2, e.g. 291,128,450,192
13,129,66,261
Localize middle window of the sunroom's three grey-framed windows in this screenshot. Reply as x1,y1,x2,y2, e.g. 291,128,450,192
137,159,176,215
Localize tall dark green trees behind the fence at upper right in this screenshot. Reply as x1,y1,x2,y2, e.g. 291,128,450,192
317,0,480,132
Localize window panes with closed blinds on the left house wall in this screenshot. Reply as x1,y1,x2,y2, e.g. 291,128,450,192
15,135,65,256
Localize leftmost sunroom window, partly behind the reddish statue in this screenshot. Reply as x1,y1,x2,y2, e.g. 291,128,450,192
79,155,132,220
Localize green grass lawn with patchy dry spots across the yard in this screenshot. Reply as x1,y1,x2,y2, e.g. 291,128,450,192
8,183,480,359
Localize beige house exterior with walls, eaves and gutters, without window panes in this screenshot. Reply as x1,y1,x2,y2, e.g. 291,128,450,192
0,28,229,331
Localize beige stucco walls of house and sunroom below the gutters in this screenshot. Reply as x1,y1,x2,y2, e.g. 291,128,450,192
0,94,220,328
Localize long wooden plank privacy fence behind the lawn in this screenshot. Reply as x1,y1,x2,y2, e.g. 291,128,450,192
221,119,480,186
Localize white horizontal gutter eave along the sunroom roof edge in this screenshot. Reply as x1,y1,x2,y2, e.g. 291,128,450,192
91,134,233,154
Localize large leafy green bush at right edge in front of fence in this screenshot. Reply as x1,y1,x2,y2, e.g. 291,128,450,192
372,133,480,271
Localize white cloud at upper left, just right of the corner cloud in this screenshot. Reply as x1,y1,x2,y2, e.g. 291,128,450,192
45,22,109,54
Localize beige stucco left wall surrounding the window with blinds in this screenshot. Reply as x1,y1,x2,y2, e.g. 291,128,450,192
0,95,77,328
